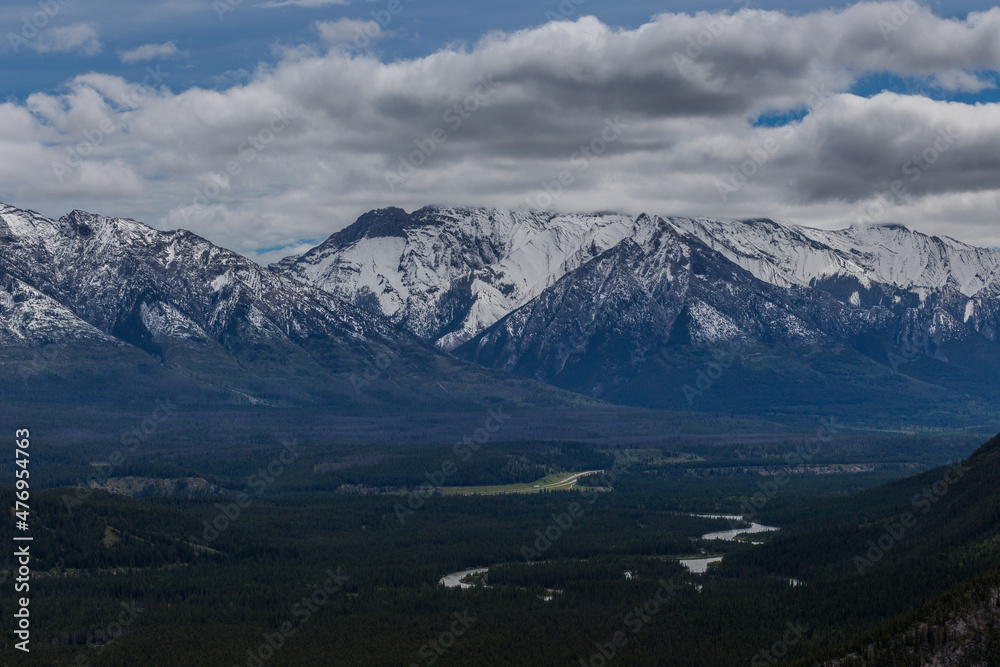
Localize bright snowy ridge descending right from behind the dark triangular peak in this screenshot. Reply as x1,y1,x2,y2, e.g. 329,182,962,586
671,218,1000,344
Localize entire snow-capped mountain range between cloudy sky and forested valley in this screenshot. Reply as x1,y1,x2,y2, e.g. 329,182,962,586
0,205,1000,420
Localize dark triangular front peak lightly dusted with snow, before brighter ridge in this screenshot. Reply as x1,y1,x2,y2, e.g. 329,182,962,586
456,216,860,396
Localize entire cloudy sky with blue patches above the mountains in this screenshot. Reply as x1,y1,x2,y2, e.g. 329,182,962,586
0,0,1000,263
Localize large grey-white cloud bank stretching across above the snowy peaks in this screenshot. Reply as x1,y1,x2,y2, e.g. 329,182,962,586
0,3,1000,259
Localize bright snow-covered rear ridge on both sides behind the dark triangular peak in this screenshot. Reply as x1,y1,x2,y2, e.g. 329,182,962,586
273,207,1000,358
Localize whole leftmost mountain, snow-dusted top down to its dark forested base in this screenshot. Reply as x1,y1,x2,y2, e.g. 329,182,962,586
0,205,564,404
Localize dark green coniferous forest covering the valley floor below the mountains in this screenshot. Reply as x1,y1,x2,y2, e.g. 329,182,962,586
0,404,1000,666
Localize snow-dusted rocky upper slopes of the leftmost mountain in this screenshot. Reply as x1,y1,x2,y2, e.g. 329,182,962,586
0,206,403,362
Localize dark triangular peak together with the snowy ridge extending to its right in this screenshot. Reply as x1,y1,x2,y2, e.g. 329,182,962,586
456,217,1000,407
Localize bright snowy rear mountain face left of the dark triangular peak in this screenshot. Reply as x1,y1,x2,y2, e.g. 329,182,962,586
274,207,633,349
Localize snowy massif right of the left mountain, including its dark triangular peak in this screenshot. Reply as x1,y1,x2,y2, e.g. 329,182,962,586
273,207,1000,412
